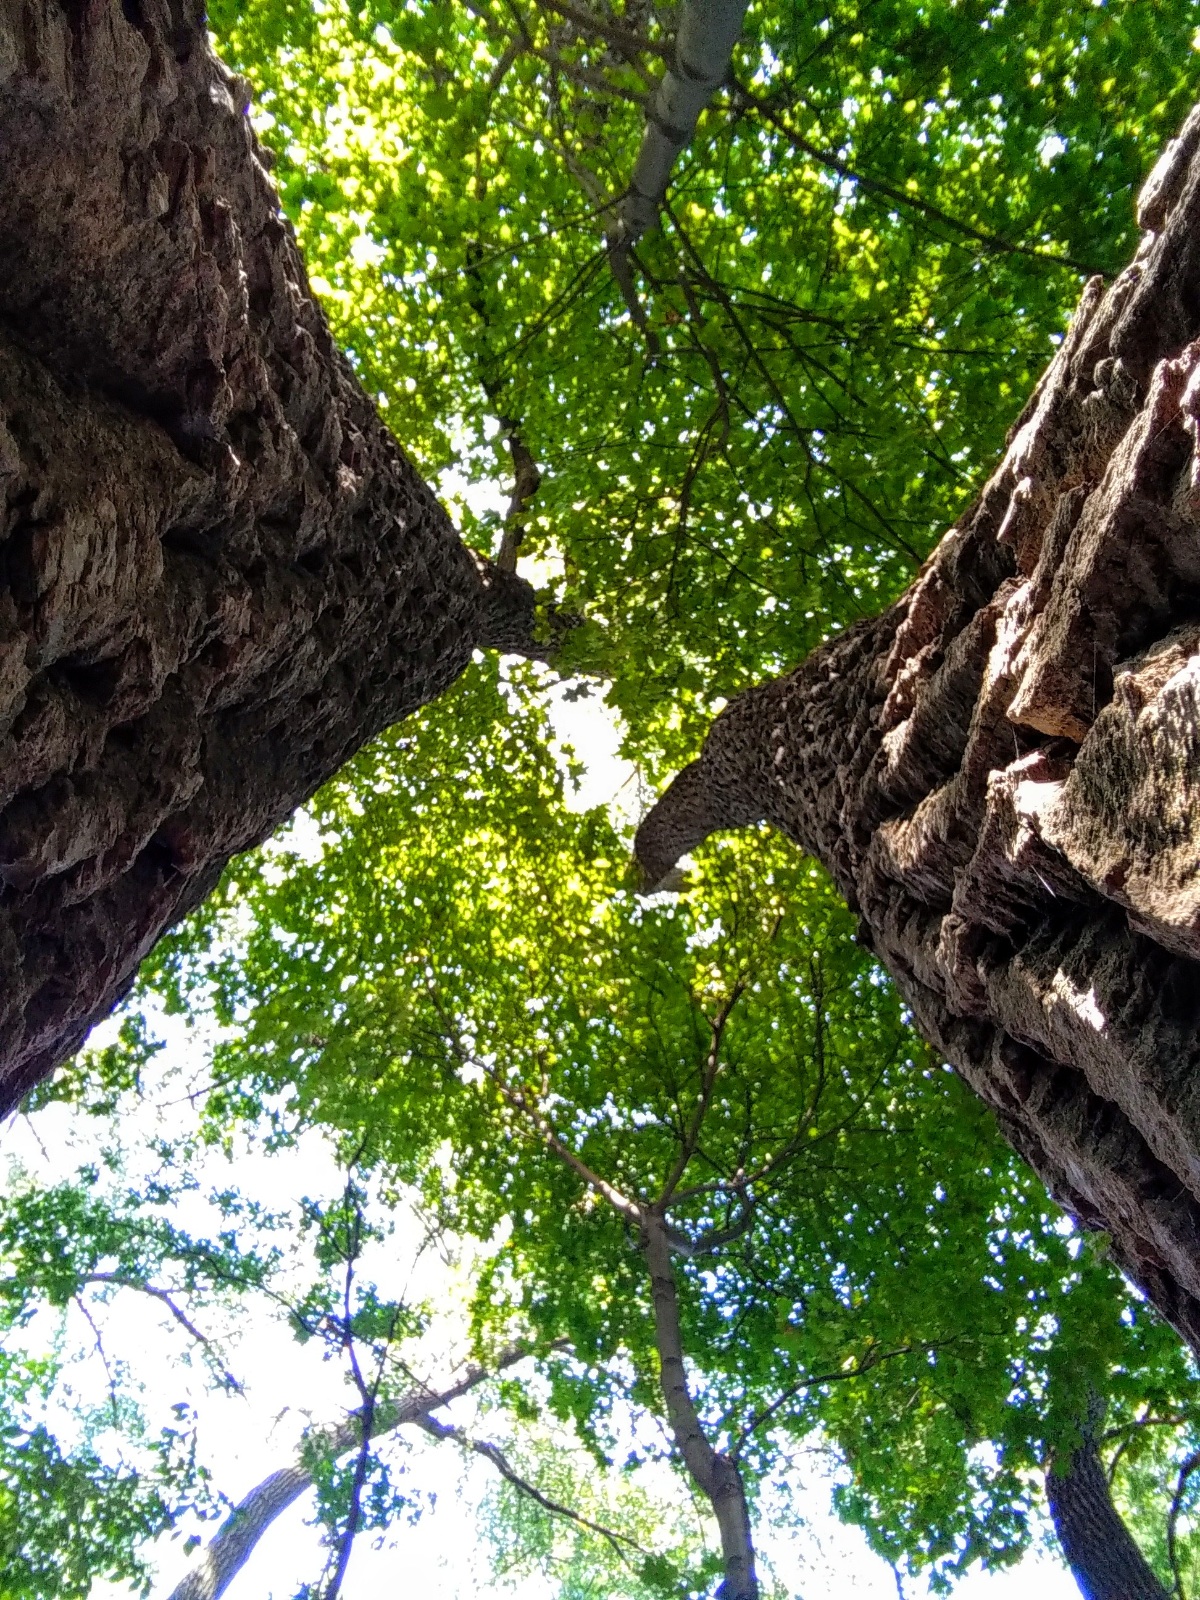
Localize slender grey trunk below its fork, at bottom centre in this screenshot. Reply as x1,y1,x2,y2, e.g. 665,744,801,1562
642,1213,758,1600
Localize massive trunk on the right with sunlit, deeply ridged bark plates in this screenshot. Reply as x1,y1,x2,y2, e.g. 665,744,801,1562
637,109,1200,1349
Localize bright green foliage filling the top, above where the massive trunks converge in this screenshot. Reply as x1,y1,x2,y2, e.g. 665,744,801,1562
211,0,1200,763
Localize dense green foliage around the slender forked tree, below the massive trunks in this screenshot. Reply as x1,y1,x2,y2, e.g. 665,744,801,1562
115,664,1192,1578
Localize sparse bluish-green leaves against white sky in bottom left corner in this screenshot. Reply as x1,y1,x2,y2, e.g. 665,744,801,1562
0,1168,269,1600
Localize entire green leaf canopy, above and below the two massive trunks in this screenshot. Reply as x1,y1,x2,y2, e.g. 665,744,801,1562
0,0,1200,1600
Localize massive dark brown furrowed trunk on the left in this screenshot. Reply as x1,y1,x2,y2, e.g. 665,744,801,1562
0,0,536,1109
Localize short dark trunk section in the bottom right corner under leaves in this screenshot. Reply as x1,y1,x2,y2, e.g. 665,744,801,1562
1046,1438,1170,1600
